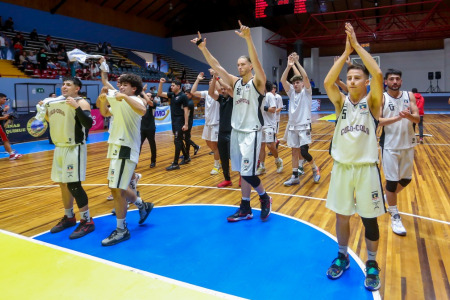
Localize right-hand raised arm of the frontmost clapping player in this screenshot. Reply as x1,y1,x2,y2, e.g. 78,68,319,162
345,23,383,119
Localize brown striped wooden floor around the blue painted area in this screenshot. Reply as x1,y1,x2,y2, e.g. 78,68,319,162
0,115,450,300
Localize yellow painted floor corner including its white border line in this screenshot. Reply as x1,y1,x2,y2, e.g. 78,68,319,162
0,230,246,300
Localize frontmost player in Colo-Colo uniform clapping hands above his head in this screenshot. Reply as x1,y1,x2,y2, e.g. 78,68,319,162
324,23,386,291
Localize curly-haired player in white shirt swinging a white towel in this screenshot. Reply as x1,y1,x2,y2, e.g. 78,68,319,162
97,74,153,246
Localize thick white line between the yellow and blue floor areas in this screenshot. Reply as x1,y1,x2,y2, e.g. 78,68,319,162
0,229,245,299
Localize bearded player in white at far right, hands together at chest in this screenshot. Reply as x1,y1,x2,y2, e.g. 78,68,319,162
379,69,420,235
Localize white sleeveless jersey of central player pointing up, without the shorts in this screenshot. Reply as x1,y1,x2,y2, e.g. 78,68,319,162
231,78,264,132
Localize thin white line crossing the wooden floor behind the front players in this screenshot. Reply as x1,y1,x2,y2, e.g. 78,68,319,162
0,183,450,225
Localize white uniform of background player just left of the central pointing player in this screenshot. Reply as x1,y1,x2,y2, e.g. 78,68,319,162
200,91,220,142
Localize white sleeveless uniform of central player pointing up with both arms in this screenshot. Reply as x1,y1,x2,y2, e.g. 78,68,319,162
230,78,264,176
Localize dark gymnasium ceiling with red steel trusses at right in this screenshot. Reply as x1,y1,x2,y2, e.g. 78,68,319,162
8,0,450,52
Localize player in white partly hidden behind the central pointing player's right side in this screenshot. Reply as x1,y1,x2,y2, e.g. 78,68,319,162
256,80,283,175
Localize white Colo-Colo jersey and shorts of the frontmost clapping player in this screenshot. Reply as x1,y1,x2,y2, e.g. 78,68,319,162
326,96,386,218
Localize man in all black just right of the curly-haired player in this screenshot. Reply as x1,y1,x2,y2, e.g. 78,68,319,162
141,93,156,168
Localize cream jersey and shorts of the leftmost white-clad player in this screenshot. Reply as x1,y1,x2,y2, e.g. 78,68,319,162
48,96,87,183
